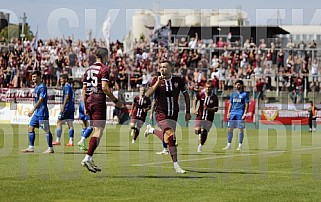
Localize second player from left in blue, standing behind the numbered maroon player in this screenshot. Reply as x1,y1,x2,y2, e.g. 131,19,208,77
52,74,75,146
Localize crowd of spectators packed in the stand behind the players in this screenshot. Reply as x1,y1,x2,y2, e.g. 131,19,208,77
0,33,320,102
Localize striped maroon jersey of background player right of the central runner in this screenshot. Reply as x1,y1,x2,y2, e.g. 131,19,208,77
196,91,218,121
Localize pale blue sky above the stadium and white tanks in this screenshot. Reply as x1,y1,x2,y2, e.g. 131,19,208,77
0,0,321,41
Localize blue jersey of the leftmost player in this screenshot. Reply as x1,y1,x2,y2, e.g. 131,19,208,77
34,83,49,117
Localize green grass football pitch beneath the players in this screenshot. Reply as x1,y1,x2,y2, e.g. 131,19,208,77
0,124,321,201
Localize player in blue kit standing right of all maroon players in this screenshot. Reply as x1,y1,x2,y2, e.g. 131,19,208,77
223,80,249,151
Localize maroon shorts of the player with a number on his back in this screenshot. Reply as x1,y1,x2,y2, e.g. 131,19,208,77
85,102,107,127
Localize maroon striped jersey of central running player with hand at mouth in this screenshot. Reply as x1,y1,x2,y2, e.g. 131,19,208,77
150,76,187,117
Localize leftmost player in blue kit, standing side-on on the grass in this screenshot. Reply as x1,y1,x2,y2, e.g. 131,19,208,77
21,71,54,154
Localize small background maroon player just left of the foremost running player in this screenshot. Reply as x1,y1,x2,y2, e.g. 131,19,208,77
129,86,151,144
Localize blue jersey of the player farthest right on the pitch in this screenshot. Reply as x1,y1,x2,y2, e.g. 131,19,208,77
230,91,249,116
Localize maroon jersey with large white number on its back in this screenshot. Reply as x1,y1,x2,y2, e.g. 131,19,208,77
83,62,109,103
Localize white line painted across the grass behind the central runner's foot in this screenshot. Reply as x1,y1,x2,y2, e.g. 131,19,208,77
132,147,321,166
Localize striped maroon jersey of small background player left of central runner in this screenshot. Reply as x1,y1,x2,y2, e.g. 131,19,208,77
132,96,151,121
